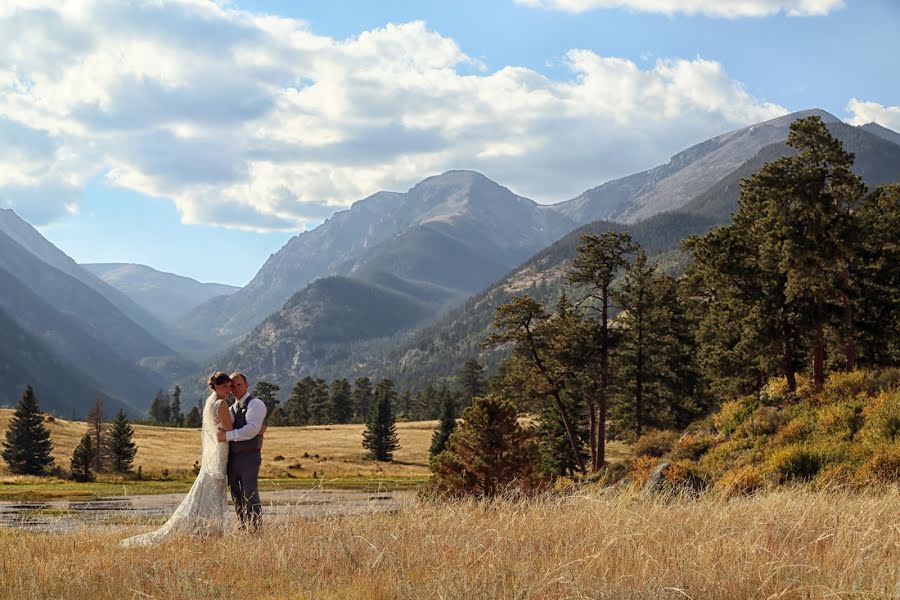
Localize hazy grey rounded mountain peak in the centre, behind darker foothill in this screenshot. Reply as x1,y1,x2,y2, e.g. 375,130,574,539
181,171,575,340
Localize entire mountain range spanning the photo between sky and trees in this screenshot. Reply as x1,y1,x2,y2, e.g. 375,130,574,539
0,110,900,413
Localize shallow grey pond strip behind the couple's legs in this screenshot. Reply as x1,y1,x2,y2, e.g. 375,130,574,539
0,488,415,533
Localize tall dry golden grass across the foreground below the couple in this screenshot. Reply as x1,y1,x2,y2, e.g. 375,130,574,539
0,488,900,600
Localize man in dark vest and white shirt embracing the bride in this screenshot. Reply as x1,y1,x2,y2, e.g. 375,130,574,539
219,373,266,533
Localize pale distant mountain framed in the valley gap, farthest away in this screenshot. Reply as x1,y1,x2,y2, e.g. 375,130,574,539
81,263,241,323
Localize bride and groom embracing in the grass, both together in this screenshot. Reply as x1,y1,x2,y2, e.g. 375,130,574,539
122,371,266,546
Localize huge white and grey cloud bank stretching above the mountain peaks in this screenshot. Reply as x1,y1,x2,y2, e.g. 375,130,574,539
0,0,788,230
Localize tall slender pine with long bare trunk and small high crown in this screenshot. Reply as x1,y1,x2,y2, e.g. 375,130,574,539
566,231,637,471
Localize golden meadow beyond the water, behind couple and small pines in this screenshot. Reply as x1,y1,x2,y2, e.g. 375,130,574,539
0,409,628,500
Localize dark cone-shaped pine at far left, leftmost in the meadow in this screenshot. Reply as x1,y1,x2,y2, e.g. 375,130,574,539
2,385,53,475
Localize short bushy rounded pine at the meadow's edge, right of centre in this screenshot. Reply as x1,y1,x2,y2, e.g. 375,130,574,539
431,395,540,498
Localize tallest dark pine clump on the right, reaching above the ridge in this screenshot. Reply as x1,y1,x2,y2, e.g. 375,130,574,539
689,117,865,391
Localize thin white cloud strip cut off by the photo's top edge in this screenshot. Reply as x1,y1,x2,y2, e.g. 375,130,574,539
515,0,844,19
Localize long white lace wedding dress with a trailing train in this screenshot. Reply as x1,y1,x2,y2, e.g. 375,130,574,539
121,393,228,547
